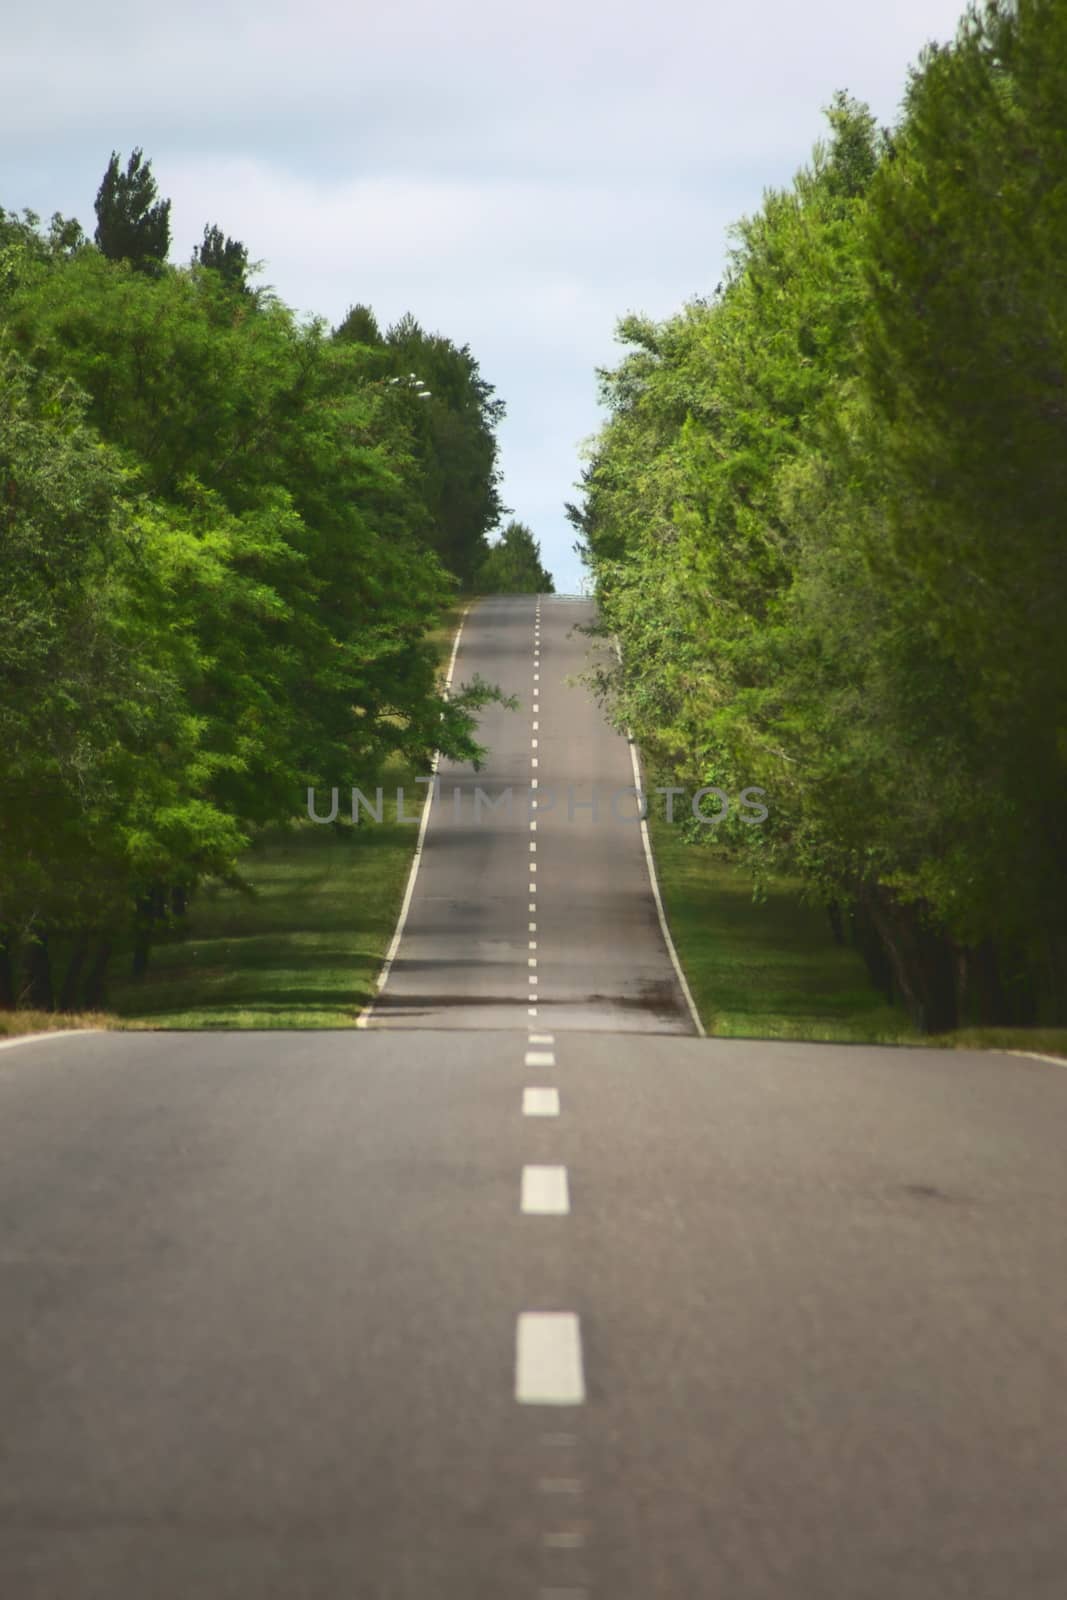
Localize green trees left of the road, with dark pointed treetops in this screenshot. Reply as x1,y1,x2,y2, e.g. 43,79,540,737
0,150,524,1010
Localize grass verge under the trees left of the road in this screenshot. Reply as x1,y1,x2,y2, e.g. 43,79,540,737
0,600,467,1034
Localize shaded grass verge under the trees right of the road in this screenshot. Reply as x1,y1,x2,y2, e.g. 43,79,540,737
649,814,1067,1056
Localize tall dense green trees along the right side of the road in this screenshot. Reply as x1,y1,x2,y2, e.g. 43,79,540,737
568,0,1067,1032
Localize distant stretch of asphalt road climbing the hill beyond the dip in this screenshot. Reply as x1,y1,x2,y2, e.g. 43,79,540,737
363,597,694,1034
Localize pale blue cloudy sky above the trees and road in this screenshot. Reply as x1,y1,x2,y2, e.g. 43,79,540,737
0,0,965,594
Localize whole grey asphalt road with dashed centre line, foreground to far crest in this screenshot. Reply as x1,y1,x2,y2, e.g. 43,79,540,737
0,598,1067,1600
